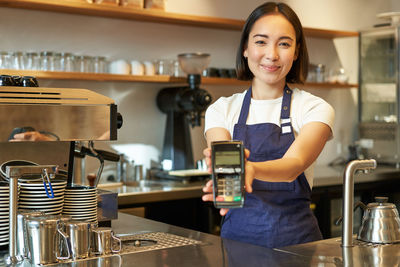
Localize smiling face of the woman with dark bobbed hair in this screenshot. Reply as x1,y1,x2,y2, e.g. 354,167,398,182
243,14,297,86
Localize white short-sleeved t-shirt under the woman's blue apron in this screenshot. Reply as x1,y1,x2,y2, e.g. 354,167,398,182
204,88,335,188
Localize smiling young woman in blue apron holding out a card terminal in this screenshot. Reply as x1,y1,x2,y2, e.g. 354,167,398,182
203,2,334,247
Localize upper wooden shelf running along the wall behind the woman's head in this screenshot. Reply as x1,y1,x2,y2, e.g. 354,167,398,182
0,0,359,39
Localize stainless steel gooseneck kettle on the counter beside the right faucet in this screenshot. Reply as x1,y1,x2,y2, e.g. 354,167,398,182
357,197,400,244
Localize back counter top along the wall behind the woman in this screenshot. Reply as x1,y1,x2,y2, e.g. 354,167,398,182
104,166,400,206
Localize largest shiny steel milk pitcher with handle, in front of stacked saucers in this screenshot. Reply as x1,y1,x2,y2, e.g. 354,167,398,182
26,216,71,265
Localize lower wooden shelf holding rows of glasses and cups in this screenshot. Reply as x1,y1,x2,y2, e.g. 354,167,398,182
0,69,358,89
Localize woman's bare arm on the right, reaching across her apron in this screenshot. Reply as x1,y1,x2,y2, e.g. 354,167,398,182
246,122,332,191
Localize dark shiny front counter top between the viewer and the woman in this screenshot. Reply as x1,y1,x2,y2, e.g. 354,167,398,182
2,213,400,267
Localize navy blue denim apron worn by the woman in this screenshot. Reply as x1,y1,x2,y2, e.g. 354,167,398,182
221,85,322,248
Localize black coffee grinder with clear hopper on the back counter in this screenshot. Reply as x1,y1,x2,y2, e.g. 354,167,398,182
157,53,212,171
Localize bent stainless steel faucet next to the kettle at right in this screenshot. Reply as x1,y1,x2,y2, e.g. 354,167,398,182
342,159,376,247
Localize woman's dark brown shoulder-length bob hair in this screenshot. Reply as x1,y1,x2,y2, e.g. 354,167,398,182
236,2,309,83
